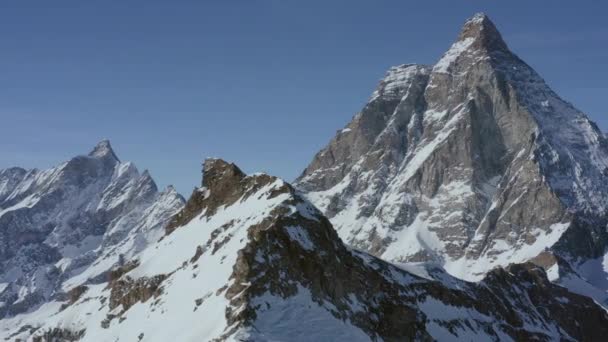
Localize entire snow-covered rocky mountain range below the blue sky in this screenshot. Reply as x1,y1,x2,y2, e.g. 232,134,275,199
0,14,608,341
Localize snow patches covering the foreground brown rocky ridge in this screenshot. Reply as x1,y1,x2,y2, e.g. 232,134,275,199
0,168,405,342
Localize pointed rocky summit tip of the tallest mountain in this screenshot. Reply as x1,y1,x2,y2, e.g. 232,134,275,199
458,13,508,50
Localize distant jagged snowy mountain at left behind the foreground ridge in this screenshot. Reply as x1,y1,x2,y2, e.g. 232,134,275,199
0,140,184,317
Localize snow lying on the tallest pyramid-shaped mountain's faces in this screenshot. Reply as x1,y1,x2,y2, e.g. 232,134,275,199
300,10,608,296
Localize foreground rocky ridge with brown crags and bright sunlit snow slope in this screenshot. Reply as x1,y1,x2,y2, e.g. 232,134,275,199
0,159,608,342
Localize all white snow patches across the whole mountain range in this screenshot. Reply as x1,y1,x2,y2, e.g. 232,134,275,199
0,14,608,341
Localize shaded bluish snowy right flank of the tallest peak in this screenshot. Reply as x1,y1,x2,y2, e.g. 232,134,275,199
498,52,608,215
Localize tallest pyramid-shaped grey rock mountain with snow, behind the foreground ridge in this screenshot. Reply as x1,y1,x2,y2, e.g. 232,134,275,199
295,14,608,303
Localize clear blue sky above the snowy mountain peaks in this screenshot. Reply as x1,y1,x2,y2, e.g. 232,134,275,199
0,0,608,195
